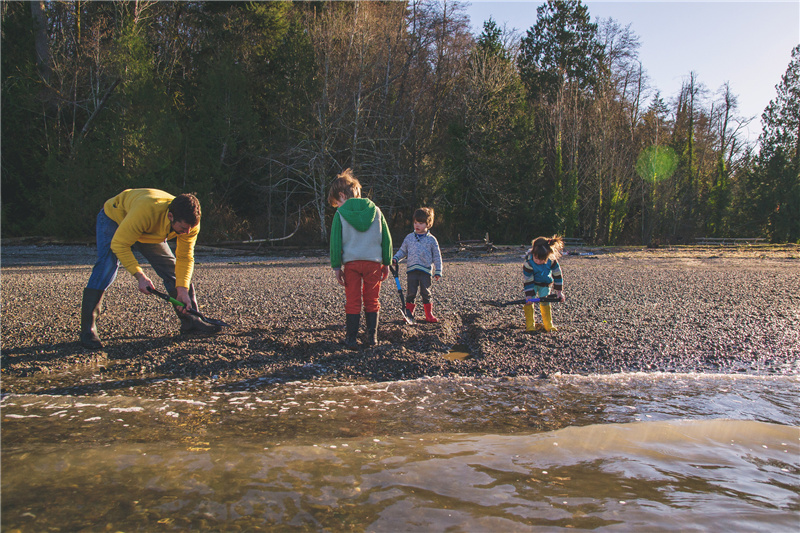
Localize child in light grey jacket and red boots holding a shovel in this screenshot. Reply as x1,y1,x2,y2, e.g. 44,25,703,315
392,207,442,322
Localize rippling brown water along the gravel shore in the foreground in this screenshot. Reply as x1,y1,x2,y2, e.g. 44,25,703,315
0,374,800,532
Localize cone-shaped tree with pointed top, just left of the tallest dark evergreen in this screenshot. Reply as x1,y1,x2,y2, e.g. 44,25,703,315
444,19,544,242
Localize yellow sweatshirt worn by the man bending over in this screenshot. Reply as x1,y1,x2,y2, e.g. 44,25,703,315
103,189,200,289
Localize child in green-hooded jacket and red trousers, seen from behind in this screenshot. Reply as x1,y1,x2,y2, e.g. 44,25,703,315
328,168,392,348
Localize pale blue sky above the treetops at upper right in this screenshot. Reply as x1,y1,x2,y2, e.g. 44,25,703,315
466,0,800,141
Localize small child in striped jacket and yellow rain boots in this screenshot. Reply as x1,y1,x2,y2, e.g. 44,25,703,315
522,235,564,331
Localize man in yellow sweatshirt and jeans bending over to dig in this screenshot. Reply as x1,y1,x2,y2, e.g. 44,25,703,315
80,189,220,349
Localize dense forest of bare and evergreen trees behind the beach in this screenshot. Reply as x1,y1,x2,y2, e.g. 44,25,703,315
0,0,800,246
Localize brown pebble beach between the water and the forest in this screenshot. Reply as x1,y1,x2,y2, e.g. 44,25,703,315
0,241,800,394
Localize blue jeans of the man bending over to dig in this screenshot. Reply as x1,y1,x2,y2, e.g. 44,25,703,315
86,209,197,309
